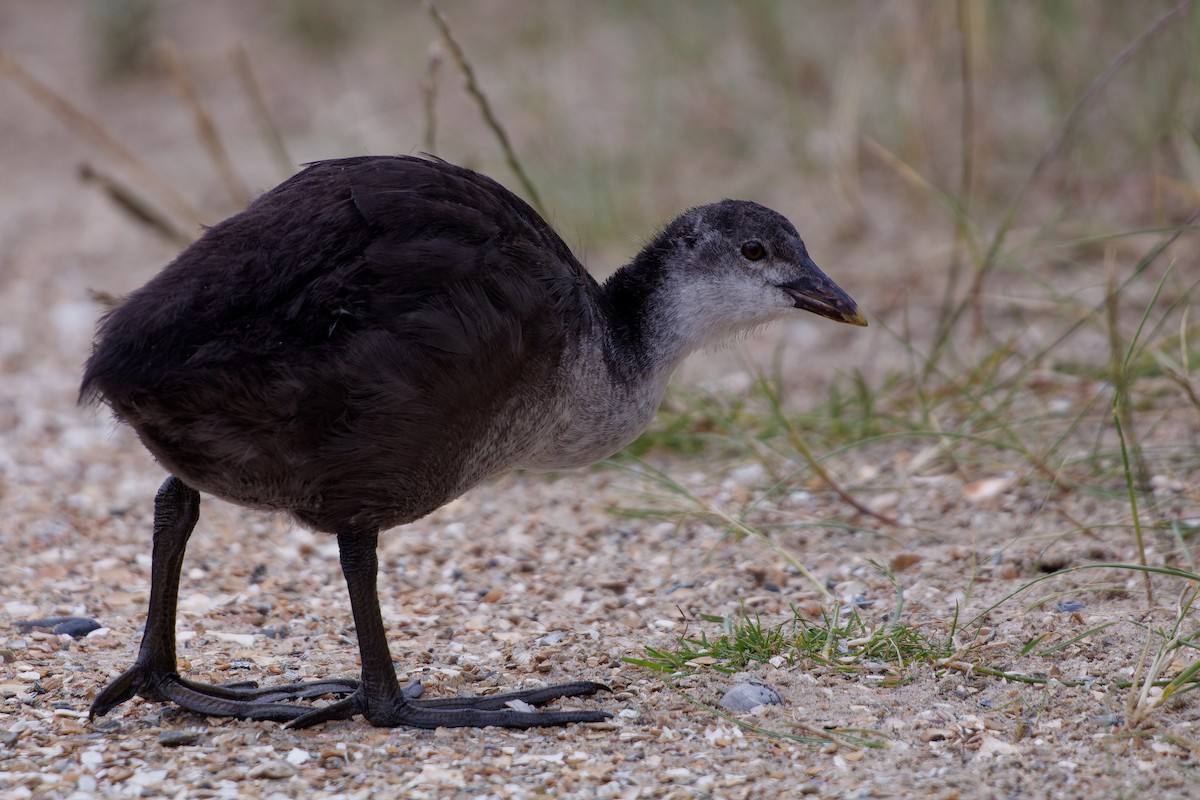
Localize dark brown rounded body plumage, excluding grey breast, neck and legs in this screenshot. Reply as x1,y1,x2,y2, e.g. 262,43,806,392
82,157,599,533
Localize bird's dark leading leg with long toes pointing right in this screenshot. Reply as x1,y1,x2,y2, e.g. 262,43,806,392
289,531,612,728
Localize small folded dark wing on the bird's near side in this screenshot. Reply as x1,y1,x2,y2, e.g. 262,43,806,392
333,157,595,403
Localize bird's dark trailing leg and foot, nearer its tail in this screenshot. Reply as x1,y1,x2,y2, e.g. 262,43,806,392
90,475,358,721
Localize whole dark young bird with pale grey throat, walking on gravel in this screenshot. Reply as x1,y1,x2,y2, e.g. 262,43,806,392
80,157,866,728
